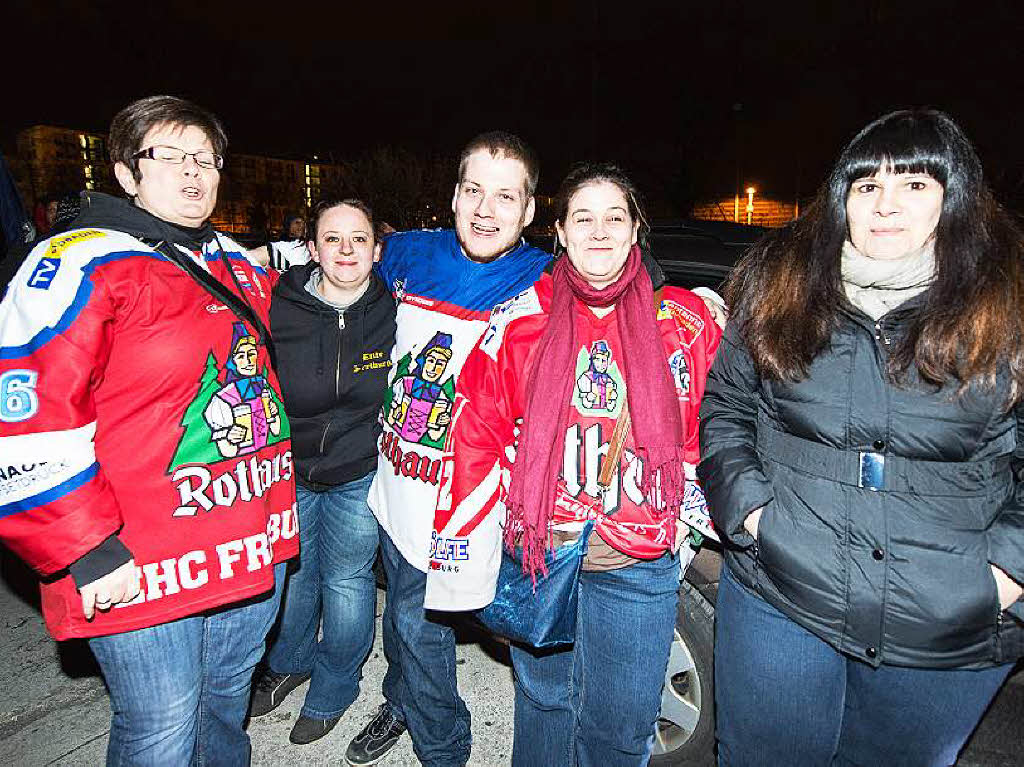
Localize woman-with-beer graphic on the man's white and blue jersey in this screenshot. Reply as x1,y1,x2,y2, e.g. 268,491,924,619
388,332,453,444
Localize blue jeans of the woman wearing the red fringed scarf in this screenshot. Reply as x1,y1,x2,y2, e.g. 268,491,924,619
512,554,679,767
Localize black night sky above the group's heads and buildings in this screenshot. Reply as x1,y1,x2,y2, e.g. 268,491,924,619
8,0,1024,209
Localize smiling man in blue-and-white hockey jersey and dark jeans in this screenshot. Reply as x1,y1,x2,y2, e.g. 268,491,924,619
345,131,550,767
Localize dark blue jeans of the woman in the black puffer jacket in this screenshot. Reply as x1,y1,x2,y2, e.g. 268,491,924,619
715,565,1013,767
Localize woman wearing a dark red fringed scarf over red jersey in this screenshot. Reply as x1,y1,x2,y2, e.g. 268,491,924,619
428,165,721,767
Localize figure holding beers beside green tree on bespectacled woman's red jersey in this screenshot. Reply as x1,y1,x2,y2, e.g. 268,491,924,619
203,323,281,458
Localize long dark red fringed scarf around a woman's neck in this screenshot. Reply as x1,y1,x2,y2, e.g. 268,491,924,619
505,245,685,574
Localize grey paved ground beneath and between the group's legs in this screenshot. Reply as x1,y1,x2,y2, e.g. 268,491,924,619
0,553,1024,767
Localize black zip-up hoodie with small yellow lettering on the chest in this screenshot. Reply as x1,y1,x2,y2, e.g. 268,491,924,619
270,262,395,489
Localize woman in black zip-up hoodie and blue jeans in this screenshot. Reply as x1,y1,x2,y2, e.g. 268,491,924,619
250,200,395,743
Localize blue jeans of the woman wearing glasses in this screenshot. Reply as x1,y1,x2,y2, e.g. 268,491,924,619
89,563,285,767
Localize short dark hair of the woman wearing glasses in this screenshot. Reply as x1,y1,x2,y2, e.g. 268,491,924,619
106,96,227,181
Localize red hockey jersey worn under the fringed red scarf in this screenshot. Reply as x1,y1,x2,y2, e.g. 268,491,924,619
426,275,721,610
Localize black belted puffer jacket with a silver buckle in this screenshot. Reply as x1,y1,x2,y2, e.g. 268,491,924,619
697,297,1024,668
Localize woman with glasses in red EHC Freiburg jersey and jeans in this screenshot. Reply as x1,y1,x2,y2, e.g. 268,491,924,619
0,96,298,767
